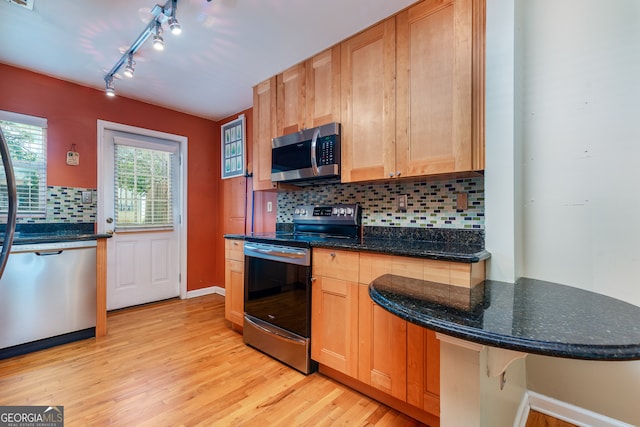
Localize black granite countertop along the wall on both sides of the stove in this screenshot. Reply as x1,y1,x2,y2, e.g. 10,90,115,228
224,227,491,263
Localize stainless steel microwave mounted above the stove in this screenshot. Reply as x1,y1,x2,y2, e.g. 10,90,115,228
271,123,340,185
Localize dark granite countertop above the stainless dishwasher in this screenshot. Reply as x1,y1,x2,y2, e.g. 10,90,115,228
0,223,111,245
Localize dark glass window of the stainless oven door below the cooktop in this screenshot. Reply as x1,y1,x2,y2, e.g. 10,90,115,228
244,257,311,338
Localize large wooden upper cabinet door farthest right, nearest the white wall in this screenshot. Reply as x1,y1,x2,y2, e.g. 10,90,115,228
396,0,484,176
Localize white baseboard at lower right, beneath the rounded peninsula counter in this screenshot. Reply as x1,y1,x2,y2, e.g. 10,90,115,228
513,390,633,427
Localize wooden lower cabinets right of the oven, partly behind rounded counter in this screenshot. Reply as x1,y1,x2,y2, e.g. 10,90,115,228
311,249,450,426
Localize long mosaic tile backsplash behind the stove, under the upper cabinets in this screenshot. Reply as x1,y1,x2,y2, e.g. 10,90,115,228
277,177,484,230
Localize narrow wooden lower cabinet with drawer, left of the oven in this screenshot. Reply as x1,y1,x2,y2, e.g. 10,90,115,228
224,239,244,328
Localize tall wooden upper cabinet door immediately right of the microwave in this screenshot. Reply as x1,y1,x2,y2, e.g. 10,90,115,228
340,18,396,182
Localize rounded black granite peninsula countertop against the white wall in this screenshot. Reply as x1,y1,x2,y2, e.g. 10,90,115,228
369,275,640,360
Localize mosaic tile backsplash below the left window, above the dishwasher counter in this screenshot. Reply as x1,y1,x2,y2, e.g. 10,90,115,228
16,186,98,224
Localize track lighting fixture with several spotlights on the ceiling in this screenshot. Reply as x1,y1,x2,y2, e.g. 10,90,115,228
104,0,182,96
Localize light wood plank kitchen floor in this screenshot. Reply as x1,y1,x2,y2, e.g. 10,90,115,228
0,295,419,427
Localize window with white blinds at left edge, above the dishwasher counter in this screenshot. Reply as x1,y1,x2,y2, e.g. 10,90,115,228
0,111,47,217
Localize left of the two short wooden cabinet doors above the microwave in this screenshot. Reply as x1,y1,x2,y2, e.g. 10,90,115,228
276,63,306,136
